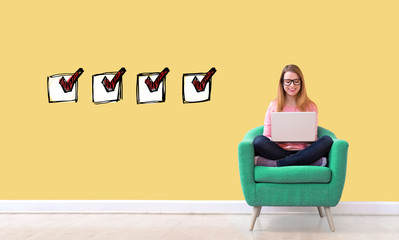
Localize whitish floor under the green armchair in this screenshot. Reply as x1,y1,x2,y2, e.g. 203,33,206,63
0,213,399,240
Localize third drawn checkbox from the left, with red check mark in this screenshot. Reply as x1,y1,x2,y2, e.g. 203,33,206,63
136,68,169,104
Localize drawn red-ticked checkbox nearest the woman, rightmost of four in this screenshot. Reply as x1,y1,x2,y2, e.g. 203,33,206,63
183,68,216,103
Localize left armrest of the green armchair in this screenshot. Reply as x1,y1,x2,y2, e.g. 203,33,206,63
238,140,255,206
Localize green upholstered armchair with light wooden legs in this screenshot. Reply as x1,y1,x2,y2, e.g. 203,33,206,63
238,126,349,231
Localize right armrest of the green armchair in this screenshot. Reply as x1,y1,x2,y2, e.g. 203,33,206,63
328,139,349,206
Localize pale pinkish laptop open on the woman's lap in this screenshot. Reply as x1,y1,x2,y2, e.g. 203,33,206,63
271,112,317,142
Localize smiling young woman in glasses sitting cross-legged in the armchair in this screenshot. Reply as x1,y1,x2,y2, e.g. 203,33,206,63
253,65,333,167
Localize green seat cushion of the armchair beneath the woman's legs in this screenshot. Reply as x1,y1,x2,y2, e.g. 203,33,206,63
255,166,331,183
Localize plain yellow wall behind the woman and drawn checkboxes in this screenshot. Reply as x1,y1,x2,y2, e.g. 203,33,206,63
0,0,399,201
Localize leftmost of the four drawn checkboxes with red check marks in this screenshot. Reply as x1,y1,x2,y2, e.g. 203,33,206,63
47,68,83,103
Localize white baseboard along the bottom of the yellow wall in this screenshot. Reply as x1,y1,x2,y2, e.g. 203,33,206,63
0,200,399,215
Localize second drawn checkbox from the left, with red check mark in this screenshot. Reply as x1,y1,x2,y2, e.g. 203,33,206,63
93,68,126,104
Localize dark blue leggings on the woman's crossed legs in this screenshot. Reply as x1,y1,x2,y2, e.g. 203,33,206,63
253,135,333,167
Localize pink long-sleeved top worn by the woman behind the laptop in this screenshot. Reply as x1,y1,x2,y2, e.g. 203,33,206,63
263,101,318,151
